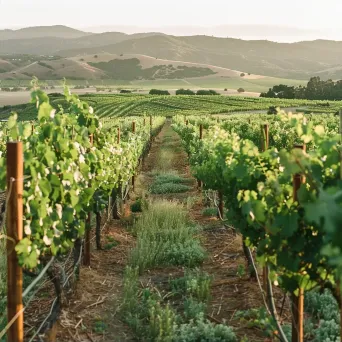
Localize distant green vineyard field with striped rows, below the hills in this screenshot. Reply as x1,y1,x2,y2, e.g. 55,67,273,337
0,94,342,120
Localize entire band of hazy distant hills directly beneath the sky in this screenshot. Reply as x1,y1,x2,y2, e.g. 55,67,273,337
0,26,342,79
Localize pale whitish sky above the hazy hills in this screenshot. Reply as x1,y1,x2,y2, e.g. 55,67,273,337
0,0,342,41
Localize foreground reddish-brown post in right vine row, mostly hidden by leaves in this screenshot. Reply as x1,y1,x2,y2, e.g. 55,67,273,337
291,145,306,342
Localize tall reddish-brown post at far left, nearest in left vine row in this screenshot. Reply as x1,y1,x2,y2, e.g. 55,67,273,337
6,142,24,342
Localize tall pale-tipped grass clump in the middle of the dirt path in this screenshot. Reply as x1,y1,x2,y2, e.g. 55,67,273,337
130,201,205,272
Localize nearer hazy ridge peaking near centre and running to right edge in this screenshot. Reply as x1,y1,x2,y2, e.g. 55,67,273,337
58,35,342,79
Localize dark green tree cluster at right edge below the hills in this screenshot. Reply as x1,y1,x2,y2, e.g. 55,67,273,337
260,76,342,100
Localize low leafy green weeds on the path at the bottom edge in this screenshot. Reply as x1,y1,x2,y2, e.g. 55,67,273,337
122,267,237,342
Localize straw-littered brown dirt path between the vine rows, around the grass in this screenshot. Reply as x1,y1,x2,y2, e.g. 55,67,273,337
58,122,284,342
